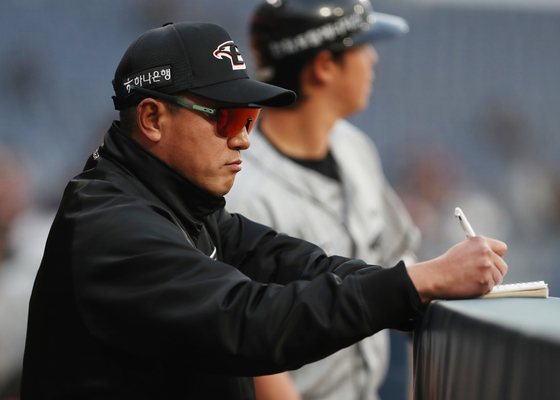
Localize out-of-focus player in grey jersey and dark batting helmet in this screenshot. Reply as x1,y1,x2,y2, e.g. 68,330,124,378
227,0,419,400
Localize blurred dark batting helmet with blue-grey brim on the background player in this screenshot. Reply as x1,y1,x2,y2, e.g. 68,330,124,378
250,0,409,68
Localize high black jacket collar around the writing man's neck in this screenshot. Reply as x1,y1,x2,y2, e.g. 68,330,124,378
99,121,225,228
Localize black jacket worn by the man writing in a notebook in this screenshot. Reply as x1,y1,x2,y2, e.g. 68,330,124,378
22,123,421,400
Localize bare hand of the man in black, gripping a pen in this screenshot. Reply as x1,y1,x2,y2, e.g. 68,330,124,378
407,236,508,303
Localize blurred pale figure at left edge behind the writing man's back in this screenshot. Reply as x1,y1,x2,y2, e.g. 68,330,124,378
0,146,52,400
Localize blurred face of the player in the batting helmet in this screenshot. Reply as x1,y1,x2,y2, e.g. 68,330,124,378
337,44,379,115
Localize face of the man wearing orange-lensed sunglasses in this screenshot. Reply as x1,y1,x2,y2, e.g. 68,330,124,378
154,95,250,196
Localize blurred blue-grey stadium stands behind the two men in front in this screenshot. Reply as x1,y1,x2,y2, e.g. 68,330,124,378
0,0,560,398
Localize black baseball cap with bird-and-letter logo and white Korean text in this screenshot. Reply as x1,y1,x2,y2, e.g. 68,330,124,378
113,22,296,110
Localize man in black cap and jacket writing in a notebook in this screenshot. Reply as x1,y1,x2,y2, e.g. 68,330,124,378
22,23,507,400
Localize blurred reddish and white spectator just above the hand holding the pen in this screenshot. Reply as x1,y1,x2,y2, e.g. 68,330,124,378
395,141,511,260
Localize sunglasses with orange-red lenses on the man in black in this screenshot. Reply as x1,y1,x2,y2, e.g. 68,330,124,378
130,85,261,138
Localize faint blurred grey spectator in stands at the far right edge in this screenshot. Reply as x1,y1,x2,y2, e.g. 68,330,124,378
479,100,560,239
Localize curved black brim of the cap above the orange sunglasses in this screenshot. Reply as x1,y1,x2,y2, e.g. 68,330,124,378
188,78,296,107
